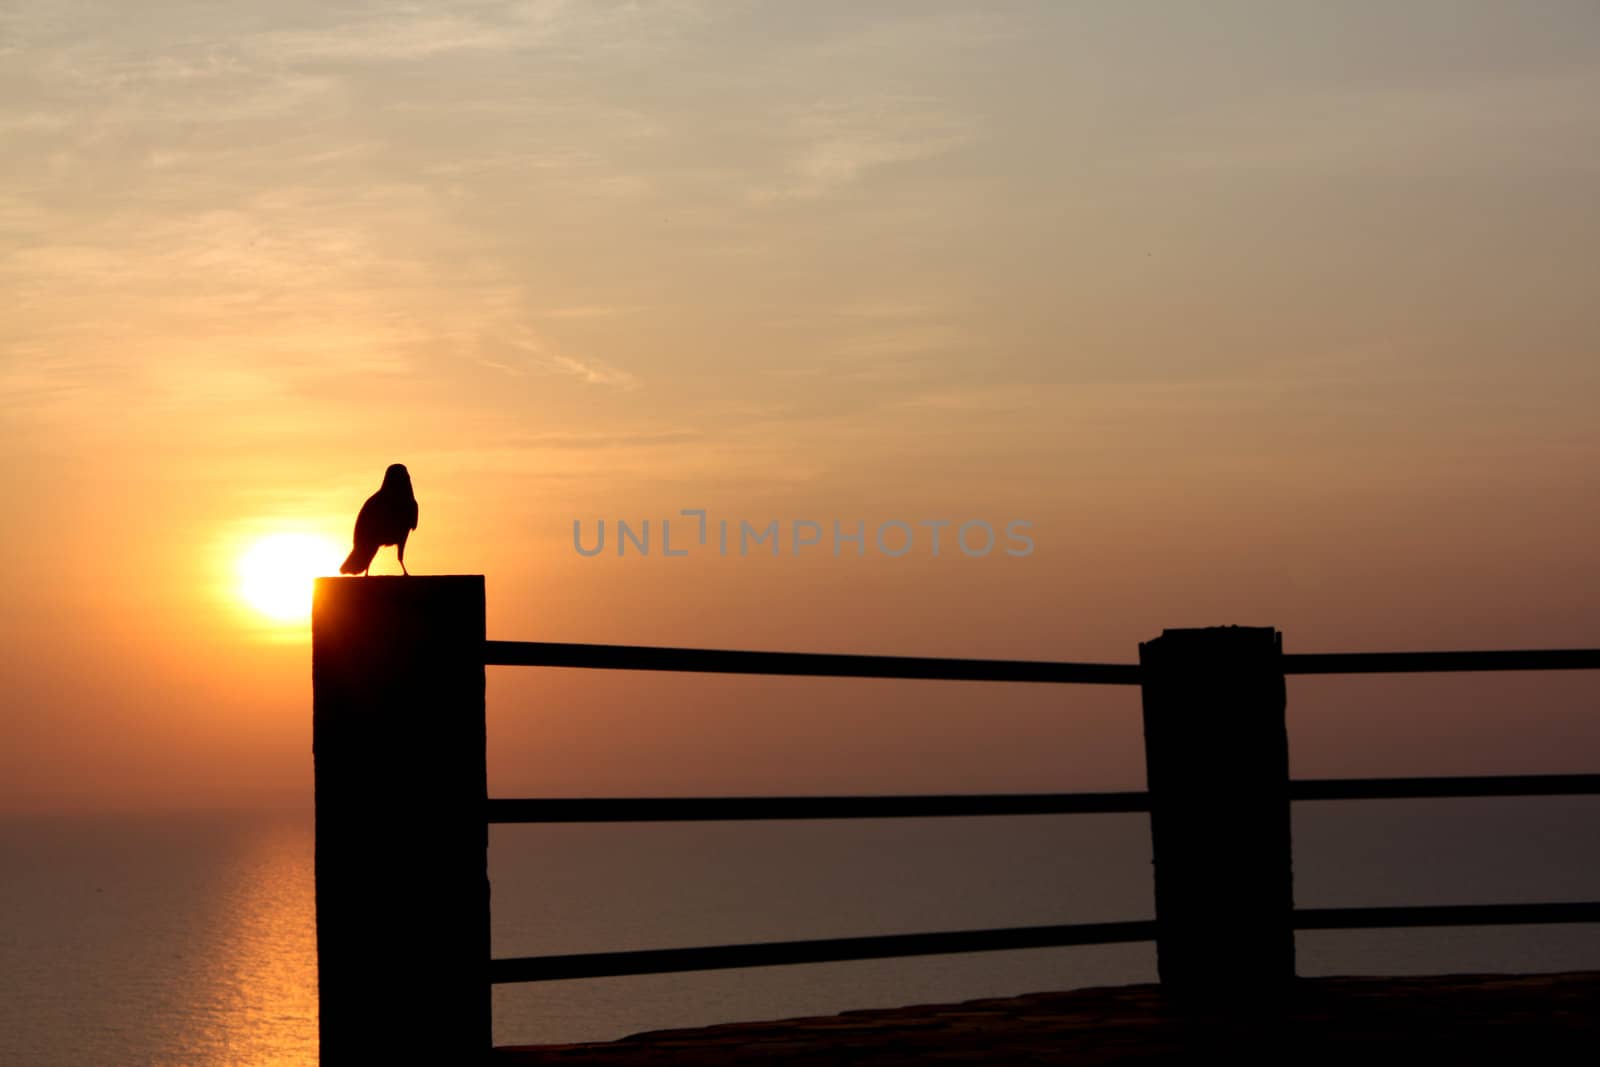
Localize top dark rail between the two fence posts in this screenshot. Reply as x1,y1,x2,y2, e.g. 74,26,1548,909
483,641,1139,685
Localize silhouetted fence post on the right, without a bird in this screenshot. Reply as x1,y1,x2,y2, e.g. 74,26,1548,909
1139,625,1294,997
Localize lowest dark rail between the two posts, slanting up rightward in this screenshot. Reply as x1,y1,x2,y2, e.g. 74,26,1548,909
490,920,1155,984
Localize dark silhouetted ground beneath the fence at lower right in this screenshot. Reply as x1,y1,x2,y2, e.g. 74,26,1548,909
494,971,1600,1067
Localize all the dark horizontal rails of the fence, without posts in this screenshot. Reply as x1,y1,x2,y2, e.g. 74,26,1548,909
483,641,1600,984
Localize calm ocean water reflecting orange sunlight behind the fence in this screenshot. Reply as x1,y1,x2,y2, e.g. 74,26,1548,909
0,798,1600,1067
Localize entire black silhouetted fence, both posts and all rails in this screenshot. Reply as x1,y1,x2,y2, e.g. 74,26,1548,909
312,576,1600,1067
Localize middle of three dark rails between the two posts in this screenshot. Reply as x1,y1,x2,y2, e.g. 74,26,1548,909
488,792,1150,822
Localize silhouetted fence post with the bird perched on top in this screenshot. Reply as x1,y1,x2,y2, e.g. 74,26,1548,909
312,574,493,1067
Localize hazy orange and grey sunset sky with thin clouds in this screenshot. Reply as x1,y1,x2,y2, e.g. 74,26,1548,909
0,0,1600,813
